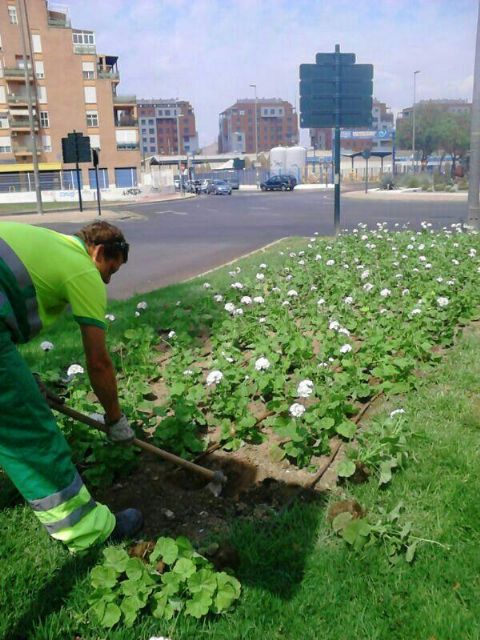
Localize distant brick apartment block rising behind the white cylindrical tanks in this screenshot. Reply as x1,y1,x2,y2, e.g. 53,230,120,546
218,98,298,153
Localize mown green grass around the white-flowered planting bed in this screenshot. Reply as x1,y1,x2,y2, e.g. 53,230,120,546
0,242,480,640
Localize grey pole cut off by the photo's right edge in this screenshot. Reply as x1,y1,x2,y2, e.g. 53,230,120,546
468,3,480,230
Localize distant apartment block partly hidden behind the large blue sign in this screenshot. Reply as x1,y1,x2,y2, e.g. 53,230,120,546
310,98,394,153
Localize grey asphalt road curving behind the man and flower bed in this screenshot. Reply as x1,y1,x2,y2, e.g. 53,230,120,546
49,191,467,298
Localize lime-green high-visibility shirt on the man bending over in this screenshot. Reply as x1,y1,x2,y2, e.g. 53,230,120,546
0,222,107,342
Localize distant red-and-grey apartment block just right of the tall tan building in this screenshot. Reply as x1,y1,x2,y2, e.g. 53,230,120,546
137,98,198,156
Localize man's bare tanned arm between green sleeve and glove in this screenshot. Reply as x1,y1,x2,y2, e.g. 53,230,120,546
80,324,122,423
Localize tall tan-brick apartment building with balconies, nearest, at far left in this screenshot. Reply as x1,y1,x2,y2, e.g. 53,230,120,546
0,0,140,190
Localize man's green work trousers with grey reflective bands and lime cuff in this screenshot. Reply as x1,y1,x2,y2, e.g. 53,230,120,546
0,319,115,551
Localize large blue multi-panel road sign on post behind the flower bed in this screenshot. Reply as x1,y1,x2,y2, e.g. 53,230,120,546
300,44,373,234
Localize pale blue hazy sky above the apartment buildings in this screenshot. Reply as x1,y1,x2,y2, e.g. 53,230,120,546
66,0,478,146
